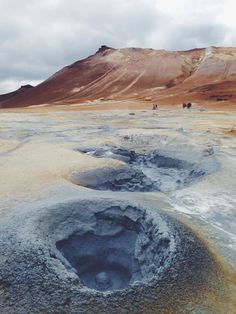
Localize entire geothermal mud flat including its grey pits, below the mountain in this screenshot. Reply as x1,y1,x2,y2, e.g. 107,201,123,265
0,109,236,314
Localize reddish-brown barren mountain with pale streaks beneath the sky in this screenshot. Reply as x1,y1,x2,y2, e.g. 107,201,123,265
0,46,236,108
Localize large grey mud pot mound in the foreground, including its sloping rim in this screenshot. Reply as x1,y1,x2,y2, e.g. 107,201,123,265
0,198,227,314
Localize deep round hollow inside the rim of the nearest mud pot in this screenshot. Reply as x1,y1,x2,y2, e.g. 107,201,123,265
56,207,175,291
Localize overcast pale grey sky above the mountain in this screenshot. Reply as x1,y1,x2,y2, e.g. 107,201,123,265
0,0,236,94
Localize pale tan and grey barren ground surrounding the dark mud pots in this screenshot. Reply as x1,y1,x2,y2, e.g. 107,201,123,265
0,101,236,314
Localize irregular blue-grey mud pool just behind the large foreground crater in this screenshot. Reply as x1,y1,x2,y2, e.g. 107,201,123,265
75,145,219,192
